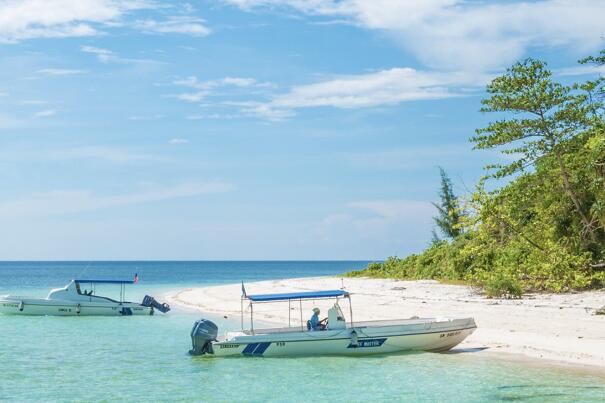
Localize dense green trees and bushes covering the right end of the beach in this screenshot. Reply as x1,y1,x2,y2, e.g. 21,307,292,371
352,50,605,297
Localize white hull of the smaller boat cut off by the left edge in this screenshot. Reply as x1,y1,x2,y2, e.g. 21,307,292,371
0,297,153,316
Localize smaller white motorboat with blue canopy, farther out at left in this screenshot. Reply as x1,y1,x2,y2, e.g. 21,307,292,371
0,276,170,316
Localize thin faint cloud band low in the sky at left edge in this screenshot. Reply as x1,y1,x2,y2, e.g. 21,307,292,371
0,182,235,218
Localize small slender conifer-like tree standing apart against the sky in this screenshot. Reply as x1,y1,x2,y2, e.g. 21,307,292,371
433,167,462,243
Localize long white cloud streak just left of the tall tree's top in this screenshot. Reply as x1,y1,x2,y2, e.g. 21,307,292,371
245,68,490,120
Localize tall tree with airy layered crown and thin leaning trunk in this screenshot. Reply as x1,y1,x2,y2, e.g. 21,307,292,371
471,58,596,243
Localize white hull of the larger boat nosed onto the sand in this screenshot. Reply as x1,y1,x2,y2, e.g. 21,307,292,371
205,318,476,356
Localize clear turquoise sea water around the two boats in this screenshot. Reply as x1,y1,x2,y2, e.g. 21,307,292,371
0,262,605,402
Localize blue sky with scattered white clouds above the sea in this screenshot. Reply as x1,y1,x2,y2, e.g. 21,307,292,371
0,0,605,260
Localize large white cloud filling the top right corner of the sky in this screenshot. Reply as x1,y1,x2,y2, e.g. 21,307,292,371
225,0,605,71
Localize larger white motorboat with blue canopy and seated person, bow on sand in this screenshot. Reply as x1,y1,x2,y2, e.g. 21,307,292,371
189,285,477,356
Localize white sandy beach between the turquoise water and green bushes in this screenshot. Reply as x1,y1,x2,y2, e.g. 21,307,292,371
168,277,605,373
